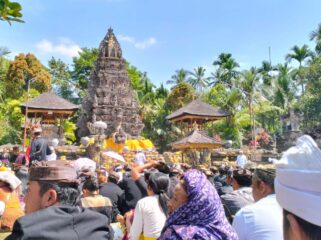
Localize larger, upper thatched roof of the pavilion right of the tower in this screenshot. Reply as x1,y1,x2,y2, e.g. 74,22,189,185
166,99,230,120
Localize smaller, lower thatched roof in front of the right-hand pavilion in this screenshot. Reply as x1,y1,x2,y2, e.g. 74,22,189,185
170,130,221,146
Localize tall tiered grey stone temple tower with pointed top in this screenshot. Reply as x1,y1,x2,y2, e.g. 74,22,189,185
77,28,144,138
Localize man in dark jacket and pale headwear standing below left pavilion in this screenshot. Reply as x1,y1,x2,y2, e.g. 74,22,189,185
30,127,52,164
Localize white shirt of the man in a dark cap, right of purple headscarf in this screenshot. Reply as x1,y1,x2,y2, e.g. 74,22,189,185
233,194,283,240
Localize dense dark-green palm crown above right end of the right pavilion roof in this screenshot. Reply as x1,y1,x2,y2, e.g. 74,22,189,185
213,53,240,88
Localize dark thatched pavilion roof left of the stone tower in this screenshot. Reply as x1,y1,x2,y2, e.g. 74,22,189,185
20,93,79,111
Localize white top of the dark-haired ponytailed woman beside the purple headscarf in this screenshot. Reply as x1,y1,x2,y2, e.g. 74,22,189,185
129,195,166,240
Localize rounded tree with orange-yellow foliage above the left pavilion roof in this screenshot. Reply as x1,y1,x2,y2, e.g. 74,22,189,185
5,53,51,98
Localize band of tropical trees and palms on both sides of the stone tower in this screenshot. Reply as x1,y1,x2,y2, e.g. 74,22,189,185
0,24,321,151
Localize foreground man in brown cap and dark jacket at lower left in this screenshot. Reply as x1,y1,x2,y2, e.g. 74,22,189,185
6,161,112,240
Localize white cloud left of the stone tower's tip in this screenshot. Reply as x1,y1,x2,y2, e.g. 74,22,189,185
36,38,81,57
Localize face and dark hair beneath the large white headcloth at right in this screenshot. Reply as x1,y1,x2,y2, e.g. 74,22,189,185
283,209,321,240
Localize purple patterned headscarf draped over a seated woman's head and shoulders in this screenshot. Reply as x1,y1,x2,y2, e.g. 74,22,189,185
159,169,238,240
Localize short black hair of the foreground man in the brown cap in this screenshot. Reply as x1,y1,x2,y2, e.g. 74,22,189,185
38,181,80,206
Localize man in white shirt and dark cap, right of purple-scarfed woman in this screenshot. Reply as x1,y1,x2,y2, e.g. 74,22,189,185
233,168,283,240
